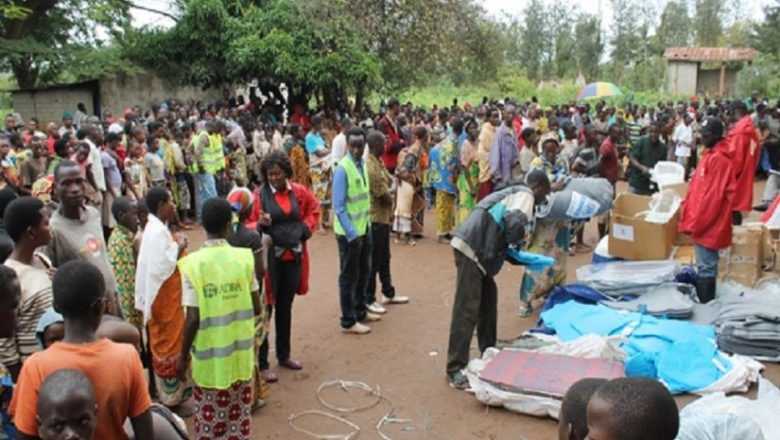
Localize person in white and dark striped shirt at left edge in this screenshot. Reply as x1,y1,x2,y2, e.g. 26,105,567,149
0,197,52,379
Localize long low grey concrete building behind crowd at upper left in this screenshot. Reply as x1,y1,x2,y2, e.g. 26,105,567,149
11,73,222,127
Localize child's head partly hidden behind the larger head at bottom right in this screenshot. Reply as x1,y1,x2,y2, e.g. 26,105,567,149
558,378,607,440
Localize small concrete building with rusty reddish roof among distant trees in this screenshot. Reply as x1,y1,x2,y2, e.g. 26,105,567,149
664,47,758,96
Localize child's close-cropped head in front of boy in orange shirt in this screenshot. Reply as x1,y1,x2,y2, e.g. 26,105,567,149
36,370,98,440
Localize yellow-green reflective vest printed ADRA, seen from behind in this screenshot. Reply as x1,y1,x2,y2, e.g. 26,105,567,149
178,244,255,390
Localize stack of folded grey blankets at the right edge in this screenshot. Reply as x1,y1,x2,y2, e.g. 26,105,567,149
714,289,780,361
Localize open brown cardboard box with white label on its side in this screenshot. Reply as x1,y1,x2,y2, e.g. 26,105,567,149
609,193,679,260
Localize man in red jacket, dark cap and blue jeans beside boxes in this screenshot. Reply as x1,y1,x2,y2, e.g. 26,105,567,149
679,118,737,303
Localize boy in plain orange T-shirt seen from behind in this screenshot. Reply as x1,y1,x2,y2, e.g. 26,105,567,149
11,260,153,440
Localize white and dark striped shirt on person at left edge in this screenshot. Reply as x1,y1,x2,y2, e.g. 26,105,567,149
0,256,52,366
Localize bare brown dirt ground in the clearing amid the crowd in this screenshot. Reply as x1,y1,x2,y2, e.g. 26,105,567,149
187,184,780,440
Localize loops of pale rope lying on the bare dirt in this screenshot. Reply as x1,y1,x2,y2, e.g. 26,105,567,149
287,380,412,440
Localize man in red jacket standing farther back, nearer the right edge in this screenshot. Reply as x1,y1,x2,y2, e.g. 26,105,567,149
726,101,761,225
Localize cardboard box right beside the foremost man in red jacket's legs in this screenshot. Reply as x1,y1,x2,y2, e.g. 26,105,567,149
718,225,765,287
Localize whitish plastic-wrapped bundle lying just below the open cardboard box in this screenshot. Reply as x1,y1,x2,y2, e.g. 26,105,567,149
577,260,681,297
